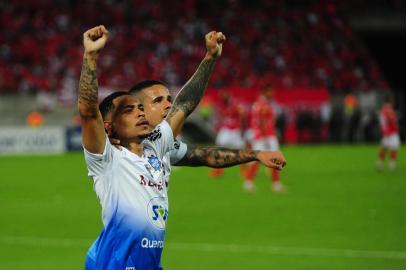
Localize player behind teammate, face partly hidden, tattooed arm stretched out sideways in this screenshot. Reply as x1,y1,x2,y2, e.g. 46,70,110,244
100,81,286,173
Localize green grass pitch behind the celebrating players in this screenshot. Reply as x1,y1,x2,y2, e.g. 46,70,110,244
0,145,406,270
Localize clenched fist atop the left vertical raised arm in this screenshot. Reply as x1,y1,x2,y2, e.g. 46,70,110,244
83,25,109,54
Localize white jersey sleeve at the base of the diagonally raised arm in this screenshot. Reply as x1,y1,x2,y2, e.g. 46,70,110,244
147,120,174,158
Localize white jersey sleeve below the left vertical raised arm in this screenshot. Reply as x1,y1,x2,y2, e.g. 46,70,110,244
83,137,115,178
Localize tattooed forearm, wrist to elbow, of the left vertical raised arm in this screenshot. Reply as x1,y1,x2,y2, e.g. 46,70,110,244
78,53,99,117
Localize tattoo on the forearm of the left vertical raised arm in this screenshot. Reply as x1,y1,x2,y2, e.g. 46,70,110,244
79,57,99,108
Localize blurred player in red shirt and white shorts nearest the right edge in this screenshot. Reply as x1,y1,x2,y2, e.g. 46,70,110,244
376,96,400,171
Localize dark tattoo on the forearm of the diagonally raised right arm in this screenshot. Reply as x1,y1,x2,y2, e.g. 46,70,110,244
167,59,216,122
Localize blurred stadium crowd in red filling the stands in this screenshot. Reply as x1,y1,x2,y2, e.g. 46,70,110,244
0,0,406,142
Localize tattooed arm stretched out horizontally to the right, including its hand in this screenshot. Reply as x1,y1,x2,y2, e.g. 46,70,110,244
175,146,286,170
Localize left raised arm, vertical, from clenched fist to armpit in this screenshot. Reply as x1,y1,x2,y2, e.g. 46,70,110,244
78,26,108,154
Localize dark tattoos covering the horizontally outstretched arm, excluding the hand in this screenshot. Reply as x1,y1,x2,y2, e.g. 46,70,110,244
175,147,258,168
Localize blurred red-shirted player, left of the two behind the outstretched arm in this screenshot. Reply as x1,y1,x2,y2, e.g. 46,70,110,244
210,91,245,177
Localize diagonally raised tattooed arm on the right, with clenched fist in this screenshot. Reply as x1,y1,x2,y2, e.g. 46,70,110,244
166,31,226,137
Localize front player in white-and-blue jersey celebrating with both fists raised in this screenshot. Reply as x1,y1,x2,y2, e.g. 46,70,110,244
78,26,225,270
